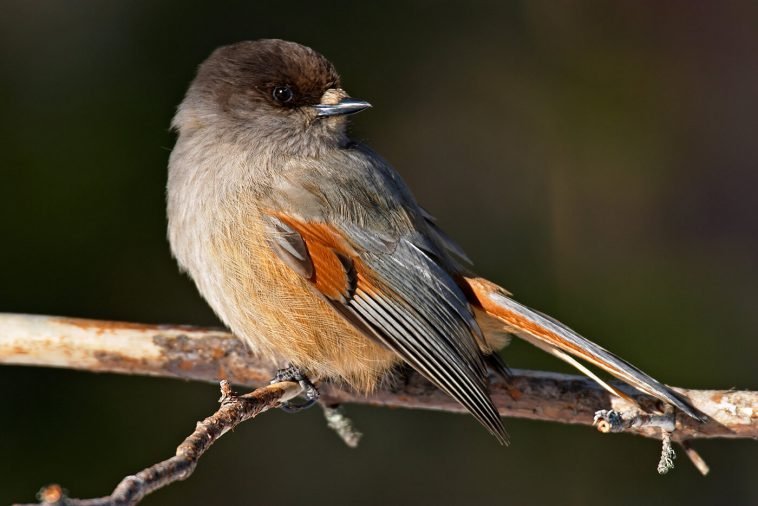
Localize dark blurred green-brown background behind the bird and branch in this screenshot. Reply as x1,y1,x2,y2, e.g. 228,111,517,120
0,0,758,505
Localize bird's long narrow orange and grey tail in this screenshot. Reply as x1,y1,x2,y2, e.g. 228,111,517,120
464,278,704,421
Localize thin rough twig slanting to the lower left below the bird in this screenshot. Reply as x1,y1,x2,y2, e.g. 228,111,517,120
17,381,302,506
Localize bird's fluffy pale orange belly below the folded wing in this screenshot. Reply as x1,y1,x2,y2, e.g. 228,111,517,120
202,210,399,391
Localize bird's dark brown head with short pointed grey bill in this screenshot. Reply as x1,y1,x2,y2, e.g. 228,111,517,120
173,39,371,148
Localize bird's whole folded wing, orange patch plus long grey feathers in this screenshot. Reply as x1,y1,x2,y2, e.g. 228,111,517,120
269,212,507,443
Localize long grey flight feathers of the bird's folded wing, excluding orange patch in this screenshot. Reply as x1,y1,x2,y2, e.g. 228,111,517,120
347,233,507,443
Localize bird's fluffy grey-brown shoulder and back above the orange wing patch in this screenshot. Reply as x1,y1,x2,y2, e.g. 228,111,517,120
266,143,470,272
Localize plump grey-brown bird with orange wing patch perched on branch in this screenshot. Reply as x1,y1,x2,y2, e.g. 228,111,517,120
167,39,701,444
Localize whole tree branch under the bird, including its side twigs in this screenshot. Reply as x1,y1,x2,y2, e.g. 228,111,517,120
0,313,758,506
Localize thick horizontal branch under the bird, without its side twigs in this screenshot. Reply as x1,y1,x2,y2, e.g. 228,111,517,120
0,314,758,442
